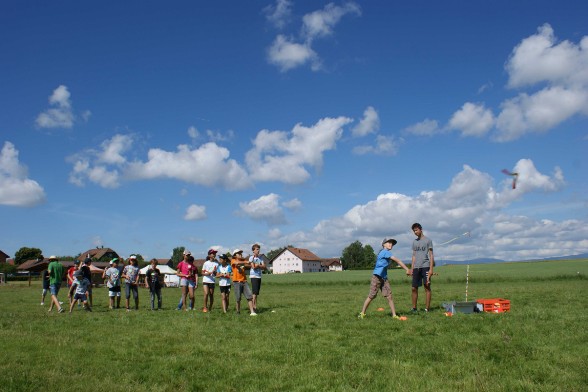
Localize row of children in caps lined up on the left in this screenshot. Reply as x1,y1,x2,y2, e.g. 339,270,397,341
41,244,266,316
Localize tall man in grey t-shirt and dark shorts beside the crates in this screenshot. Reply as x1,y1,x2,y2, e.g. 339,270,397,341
410,223,435,313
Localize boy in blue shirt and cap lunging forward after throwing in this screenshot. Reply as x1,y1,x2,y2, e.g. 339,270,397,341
358,238,410,320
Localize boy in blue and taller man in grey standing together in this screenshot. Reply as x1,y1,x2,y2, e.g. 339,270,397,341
358,223,435,320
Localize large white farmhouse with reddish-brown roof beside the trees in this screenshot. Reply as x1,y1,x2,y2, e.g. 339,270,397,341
272,247,342,274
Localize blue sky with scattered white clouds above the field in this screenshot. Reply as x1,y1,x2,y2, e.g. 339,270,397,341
0,0,588,260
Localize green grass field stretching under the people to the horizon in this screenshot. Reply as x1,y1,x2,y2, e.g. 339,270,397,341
0,260,588,391
